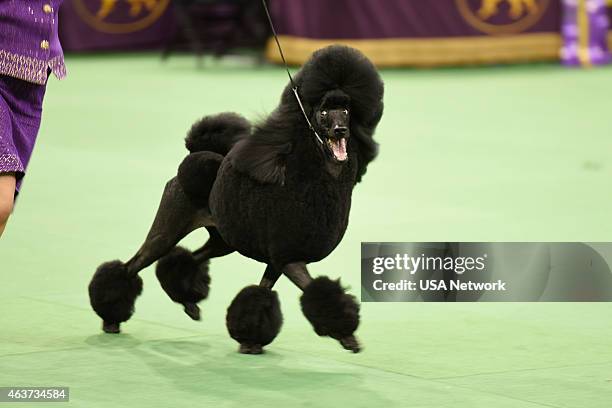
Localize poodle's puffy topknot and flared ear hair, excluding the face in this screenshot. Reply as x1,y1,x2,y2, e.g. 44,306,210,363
231,45,384,184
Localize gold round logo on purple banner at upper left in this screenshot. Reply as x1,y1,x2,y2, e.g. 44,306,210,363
72,0,170,34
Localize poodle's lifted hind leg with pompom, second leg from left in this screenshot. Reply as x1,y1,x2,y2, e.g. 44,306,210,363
155,227,234,320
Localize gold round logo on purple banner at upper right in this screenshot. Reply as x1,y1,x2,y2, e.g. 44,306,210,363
455,0,550,35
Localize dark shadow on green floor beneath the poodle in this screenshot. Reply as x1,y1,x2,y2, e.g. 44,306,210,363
119,340,393,407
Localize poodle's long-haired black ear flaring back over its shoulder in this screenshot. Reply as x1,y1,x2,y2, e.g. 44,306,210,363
228,137,291,185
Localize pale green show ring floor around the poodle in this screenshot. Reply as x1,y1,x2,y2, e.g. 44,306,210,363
0,55,612,408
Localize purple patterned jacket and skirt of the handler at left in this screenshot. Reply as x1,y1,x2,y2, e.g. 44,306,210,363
0,0,66,190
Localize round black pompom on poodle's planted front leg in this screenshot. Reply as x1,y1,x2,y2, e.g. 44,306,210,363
226,285,283,354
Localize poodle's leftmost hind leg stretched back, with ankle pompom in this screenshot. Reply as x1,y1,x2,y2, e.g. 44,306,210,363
89,177,210,333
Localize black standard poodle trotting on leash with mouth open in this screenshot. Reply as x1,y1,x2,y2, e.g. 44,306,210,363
89,45,383,354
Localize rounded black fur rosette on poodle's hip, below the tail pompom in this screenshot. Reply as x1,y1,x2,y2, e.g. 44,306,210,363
177,151,223,207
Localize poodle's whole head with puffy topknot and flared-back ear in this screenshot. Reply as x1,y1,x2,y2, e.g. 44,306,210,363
232,45,384,185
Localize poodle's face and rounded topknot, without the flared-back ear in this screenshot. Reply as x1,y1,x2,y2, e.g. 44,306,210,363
283,45,384,163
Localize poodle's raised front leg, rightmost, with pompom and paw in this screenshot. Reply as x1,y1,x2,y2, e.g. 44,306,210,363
283,263,361,353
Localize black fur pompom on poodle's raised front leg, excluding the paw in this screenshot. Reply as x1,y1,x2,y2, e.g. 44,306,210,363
300,276,359,340
